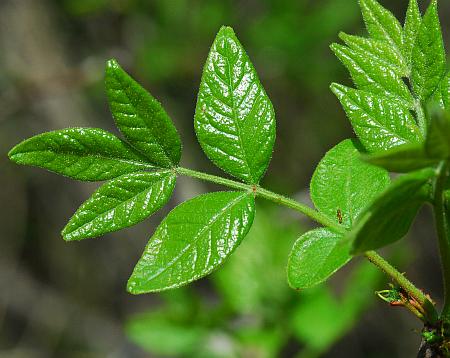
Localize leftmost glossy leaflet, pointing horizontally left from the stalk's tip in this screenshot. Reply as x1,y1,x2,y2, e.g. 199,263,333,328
8,128,150,181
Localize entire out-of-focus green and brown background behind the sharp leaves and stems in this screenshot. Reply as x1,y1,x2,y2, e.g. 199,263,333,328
0,0,450,358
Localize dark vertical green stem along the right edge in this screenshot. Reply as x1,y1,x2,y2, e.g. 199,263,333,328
434,161,450,321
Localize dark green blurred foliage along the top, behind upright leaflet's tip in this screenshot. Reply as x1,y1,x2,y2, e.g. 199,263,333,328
60,0,359,86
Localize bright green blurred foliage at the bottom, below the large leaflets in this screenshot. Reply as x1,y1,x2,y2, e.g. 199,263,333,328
126,208,382,358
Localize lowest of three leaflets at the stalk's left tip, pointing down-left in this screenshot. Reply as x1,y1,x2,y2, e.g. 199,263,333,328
62,171,176,241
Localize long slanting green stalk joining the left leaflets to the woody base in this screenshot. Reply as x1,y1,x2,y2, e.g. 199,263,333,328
175,167,432,318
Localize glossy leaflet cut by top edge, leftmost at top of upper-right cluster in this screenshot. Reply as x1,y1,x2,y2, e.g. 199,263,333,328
359,0,403,62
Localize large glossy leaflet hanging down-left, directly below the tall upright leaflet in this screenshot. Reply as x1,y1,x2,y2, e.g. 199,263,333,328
127,192,255,294
